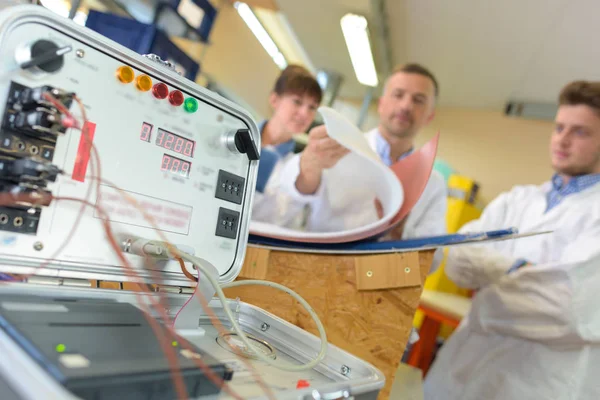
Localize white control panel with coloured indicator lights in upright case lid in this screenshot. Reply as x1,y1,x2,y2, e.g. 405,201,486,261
0,8,260,284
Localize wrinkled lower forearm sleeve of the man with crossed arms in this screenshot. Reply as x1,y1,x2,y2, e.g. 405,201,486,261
469,239,600,346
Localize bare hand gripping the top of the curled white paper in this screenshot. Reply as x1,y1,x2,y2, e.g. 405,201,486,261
296,125,350,194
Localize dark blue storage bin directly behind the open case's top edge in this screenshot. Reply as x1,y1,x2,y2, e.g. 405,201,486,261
85,10,200,81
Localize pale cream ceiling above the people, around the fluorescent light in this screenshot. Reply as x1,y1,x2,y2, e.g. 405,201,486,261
277,0,600,109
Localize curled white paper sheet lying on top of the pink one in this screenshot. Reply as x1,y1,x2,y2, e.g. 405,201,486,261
250,107,404,242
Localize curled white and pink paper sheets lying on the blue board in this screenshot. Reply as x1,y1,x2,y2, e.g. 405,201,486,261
250,107,438,243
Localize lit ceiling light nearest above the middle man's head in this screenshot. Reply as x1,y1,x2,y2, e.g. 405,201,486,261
341,14,379,87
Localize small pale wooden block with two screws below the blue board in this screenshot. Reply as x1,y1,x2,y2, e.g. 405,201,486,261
354,253,421,290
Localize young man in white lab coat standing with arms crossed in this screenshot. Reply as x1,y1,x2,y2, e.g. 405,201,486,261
425,82,600,400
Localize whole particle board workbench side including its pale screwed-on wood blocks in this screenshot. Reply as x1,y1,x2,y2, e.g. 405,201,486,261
225,245,434,399
